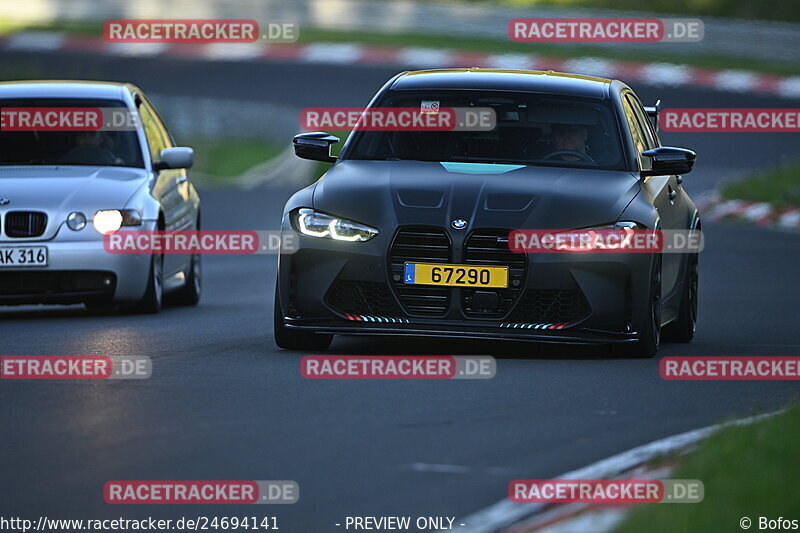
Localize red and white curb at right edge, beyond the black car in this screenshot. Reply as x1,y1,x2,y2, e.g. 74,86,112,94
695,191,800,229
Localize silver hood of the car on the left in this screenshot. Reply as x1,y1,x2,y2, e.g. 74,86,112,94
0,166,149,239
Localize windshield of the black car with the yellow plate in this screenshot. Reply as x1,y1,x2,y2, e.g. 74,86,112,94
343,90,625,170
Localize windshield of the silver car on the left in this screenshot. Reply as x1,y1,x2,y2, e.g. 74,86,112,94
0,98,144,168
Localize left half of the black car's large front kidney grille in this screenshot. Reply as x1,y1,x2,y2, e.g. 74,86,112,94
389,226,450,316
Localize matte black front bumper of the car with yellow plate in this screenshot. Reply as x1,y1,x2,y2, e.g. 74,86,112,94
278,222,652,343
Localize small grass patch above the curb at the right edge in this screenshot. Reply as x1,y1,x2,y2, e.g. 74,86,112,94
721,162,800,208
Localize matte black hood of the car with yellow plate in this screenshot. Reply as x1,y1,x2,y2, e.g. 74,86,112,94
313,160,639,230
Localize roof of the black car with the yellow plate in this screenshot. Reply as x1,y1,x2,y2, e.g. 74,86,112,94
391,67,613,98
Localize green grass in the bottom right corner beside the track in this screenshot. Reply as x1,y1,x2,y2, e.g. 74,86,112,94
616,407,800,533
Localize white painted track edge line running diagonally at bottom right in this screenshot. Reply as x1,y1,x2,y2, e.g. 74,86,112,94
458,410,783,533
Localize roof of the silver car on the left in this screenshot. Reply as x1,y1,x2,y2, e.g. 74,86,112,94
0,80,137,100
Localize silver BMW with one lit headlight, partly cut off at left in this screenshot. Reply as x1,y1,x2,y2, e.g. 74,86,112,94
0,81,201,313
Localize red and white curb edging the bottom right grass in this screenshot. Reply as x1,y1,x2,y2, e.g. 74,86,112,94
457,410,783,533
